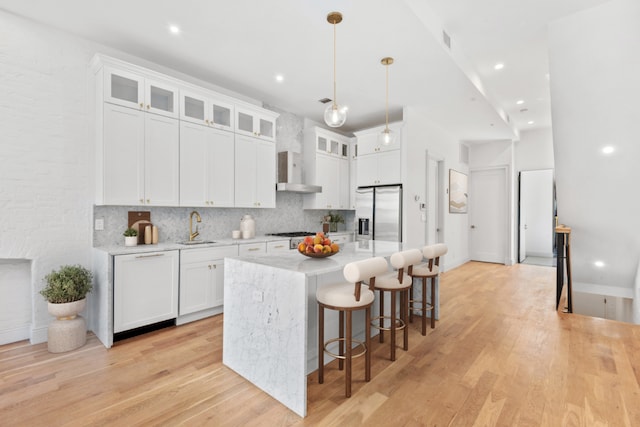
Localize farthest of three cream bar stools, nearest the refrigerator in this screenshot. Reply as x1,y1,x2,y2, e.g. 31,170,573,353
409,243,448,335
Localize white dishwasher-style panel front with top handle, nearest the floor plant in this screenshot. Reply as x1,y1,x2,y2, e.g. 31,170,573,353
113,250,179,333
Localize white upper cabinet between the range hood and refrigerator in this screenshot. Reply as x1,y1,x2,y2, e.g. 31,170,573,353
304,127,350,209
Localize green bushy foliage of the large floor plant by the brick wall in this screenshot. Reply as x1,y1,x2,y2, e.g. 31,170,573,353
40,265,93,304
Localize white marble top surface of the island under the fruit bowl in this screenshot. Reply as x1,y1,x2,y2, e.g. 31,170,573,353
231,240,405,275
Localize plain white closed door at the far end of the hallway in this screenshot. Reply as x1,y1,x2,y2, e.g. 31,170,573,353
469,168,508,264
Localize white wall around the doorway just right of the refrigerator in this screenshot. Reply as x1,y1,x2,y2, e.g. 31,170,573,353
402,107,469,269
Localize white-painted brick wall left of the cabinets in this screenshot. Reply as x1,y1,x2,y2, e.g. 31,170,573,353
0,12,96,342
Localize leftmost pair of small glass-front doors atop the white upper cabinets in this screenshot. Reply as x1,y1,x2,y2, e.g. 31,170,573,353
104,67,178,118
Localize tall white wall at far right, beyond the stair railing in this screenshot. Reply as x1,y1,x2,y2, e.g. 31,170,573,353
548,0,640,294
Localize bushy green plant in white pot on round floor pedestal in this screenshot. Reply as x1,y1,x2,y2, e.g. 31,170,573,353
40,265,92,353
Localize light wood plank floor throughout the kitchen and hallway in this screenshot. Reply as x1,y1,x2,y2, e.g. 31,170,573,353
0,263,640,426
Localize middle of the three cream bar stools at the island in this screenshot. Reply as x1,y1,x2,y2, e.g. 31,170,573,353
371,249,422,361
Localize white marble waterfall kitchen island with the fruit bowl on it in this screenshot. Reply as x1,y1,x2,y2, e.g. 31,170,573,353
223,241,437,417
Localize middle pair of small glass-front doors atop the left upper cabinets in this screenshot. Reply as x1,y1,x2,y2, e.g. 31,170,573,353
180,90,234,131
